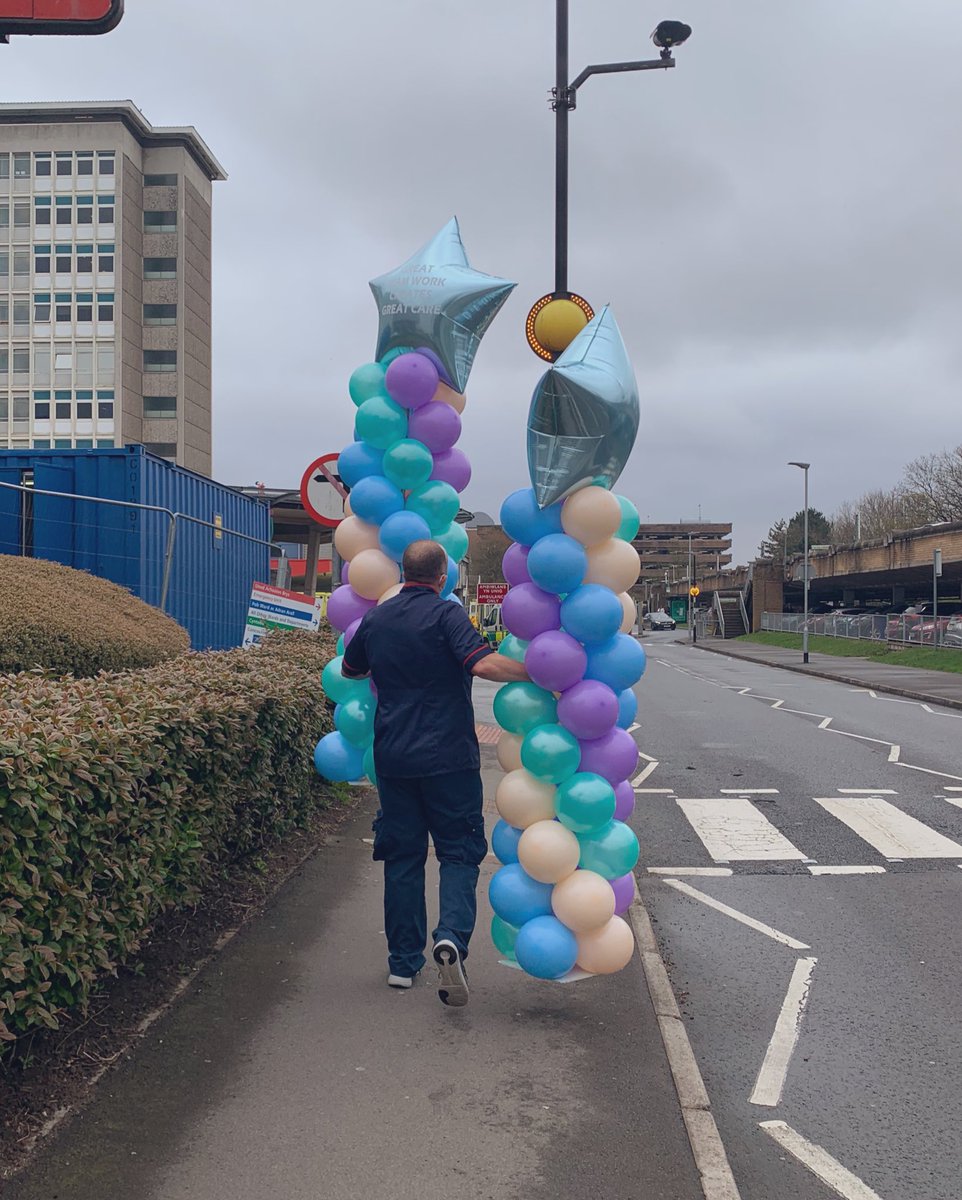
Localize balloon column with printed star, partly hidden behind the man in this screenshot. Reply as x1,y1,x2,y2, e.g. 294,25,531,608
314,220,515,781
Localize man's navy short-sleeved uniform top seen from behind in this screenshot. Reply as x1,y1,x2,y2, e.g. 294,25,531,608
341,583,494,779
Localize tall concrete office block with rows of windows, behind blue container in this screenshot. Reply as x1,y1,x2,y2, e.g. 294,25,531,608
0,101,227,475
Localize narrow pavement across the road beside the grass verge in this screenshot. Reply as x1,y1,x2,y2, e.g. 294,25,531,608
697,637,962,709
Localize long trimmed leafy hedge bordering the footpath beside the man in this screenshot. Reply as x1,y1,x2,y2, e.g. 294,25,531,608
0,632,333,1042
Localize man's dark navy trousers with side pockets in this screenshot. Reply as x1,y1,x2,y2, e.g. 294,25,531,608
374,770,488,977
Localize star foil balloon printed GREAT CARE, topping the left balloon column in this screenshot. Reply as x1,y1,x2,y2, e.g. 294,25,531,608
371,217,517,391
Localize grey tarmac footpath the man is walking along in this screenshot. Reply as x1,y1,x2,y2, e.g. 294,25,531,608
2,689,702,1200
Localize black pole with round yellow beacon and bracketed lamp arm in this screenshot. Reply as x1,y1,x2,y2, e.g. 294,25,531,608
525,7,691,362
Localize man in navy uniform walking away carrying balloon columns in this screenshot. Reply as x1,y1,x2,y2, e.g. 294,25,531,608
341,541,528,1006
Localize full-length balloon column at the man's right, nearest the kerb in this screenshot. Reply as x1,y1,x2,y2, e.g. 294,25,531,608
489,308,645,979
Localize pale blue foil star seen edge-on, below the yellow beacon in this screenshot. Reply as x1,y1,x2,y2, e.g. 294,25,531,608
528,305,641,509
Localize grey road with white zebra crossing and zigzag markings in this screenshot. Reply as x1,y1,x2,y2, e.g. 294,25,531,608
633,635,962,1200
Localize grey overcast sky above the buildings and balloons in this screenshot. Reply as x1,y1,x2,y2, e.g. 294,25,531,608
0,0,962,560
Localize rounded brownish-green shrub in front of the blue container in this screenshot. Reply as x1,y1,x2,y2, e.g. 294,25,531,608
0,554,191,676
